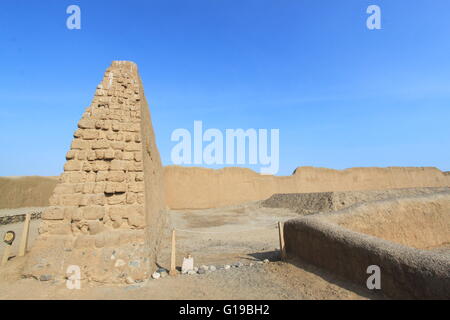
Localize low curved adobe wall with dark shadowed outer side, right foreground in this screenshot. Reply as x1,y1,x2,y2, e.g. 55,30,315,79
284,192,450,300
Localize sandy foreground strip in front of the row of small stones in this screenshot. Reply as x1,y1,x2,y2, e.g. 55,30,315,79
0,262,381,300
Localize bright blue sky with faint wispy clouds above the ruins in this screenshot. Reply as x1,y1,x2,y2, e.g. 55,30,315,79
0,0,450,176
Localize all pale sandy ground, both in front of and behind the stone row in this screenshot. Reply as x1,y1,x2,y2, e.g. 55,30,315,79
0,203,383,299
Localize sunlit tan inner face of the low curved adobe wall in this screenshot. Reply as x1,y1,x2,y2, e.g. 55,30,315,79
327,191,450,249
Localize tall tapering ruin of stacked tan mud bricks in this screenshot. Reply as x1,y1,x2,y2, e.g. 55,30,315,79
24,61,165,282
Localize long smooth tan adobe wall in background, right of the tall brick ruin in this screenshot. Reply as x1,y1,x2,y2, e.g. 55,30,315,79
164,166,450,209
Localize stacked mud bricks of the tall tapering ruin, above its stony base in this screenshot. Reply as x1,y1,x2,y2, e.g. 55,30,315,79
24,61,165,284
